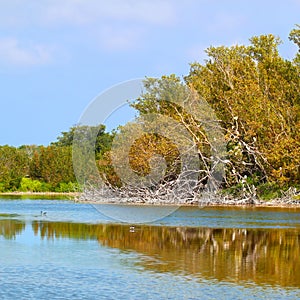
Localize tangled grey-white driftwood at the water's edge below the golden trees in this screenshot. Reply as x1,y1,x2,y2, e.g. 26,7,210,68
76,185,300,207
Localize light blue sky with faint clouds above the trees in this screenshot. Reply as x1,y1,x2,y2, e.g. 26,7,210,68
0,0,300,146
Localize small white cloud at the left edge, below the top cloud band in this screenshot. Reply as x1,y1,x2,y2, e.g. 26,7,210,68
0,38,52,66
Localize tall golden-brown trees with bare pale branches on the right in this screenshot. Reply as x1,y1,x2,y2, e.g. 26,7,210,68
102,25,300,199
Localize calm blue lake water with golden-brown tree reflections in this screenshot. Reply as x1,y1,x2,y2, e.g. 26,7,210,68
0,198,300,299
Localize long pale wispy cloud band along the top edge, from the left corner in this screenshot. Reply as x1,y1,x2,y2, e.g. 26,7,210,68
0,0,178,26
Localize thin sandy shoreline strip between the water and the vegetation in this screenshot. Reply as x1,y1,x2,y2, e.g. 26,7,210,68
0,191,300,208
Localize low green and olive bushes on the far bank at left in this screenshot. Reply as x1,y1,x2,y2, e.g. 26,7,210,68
0,146,76,192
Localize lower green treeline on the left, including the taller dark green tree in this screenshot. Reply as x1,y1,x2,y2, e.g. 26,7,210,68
0,125,112,192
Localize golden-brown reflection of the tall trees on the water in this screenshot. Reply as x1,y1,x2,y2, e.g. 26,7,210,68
32,221,300,287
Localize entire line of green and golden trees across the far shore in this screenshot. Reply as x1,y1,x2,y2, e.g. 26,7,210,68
0,25,300,198
